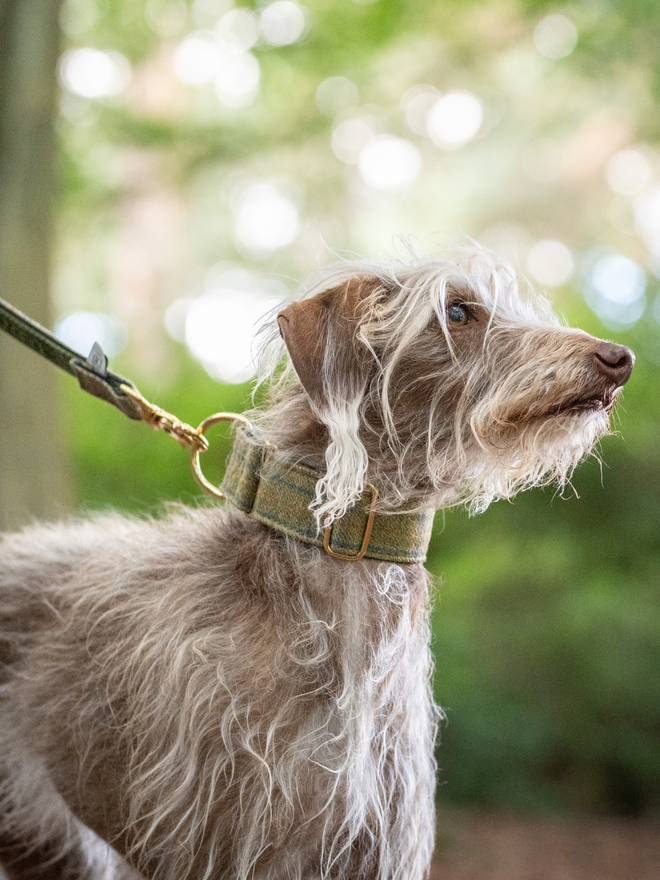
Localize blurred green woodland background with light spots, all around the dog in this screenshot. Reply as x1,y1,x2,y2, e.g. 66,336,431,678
0,0,660,878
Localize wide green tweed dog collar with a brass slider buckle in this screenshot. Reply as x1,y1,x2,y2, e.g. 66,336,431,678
222,428,434,563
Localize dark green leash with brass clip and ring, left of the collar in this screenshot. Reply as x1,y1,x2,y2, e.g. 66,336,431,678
0,298,242,498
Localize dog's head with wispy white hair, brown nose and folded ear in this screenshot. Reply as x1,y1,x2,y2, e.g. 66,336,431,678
270,248,634,524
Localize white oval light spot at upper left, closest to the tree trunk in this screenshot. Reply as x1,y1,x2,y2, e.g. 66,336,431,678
59,49,131,98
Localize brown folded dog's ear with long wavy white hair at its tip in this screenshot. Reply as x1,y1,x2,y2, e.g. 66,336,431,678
277,278,379,525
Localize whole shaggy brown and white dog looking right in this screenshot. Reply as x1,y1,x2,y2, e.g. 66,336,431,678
0,246,634,880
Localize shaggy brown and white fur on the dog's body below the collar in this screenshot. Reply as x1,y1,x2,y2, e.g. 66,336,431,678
0,510,435,880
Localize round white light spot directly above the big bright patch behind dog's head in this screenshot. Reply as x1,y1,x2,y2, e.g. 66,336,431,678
235,183,300,254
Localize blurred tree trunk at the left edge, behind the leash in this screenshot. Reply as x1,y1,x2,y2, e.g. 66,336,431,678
0,0,69,529
